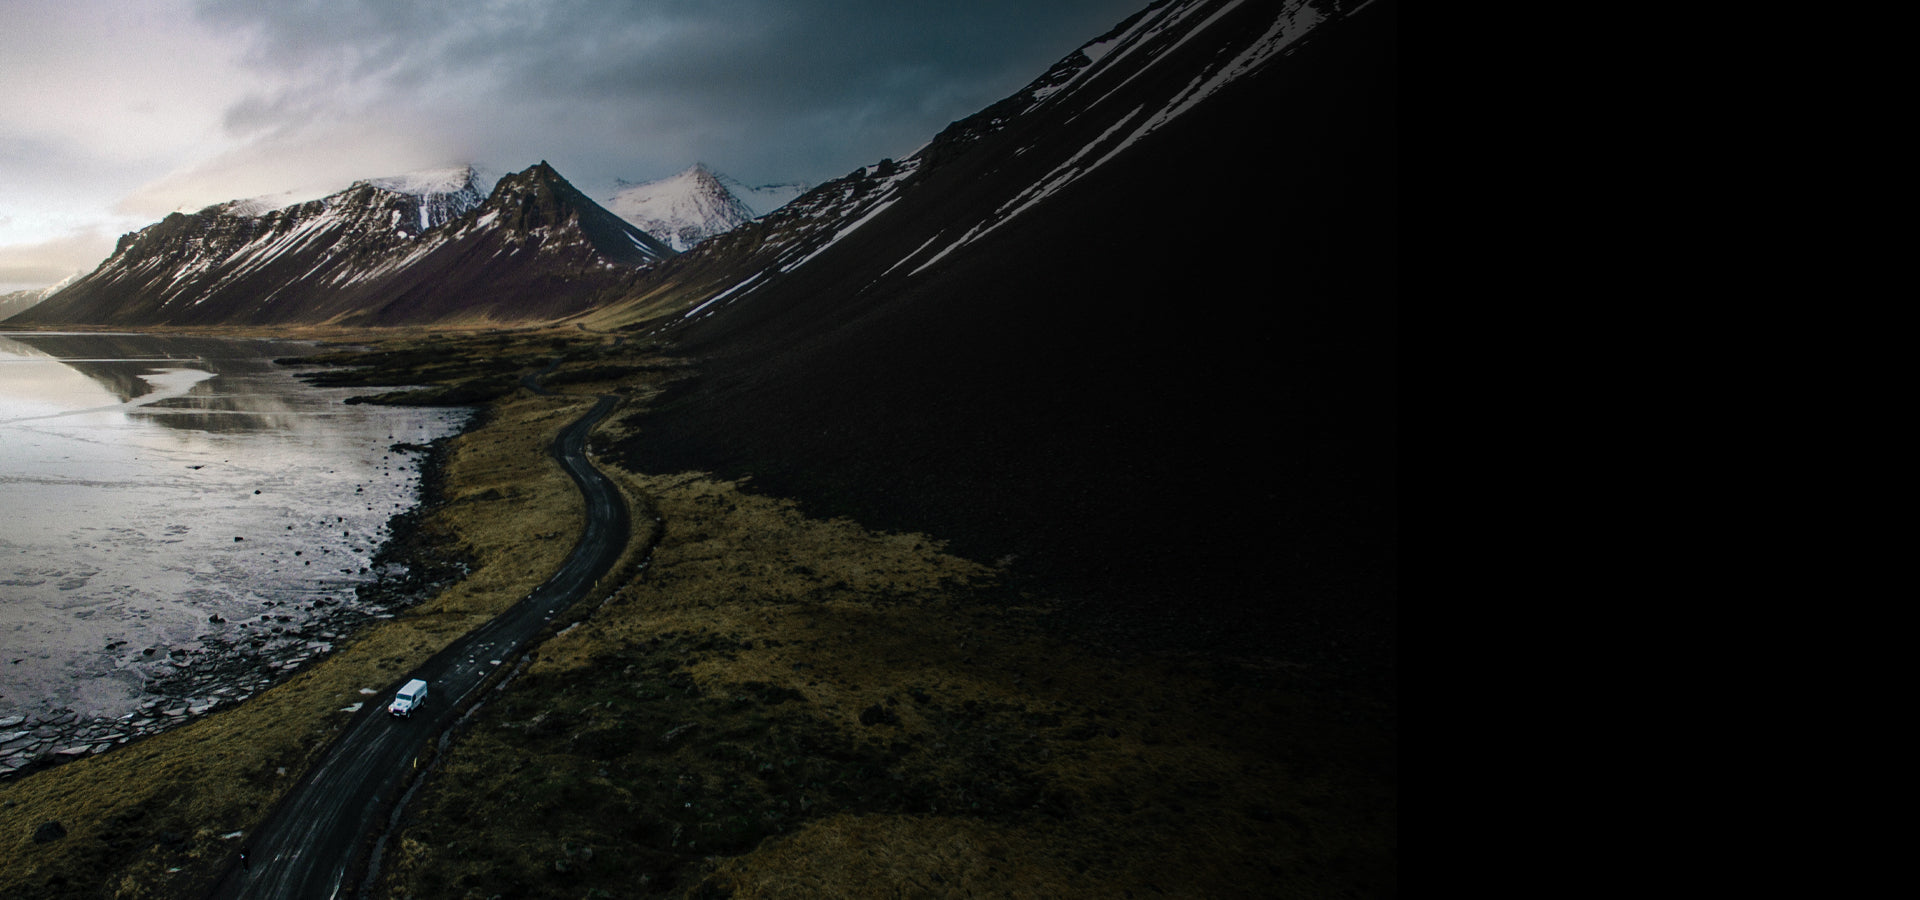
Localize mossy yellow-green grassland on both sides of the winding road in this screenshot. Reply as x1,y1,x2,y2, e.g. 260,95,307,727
0,334,1398,898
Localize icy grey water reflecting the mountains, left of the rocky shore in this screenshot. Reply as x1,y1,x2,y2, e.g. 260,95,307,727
0,332,468,756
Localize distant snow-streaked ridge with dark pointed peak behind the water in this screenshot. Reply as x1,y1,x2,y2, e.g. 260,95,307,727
21,163,674,324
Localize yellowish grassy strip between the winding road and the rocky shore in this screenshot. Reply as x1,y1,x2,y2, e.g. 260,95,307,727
0,332,602,898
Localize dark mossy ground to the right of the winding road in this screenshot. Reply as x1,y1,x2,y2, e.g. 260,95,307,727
384,435,1396,898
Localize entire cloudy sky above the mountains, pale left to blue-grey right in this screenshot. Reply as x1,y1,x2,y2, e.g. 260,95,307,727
0,0,1148,294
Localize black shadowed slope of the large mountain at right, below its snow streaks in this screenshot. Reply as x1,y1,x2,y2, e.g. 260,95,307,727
626,2,1398,662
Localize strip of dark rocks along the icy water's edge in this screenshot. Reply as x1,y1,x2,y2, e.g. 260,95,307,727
0,435,474,781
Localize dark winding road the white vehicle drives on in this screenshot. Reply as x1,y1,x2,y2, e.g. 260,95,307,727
211,397,630,900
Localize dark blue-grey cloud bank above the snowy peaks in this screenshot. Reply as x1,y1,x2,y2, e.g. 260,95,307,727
187,0,1144,186
